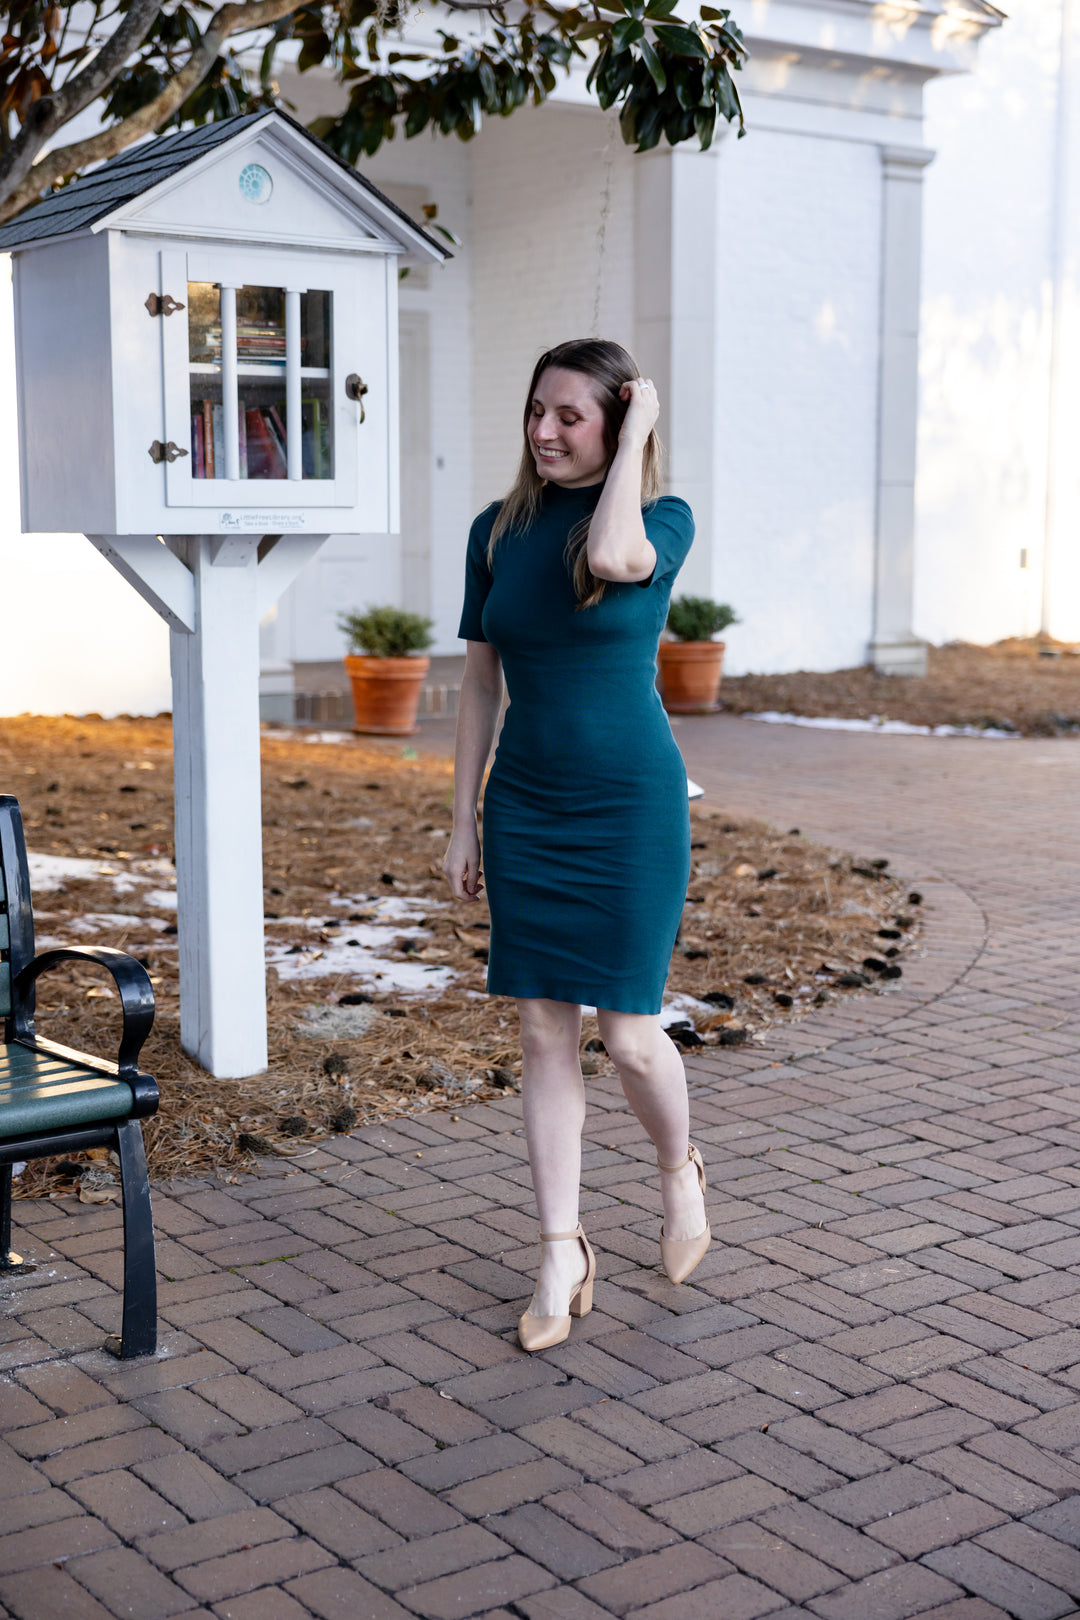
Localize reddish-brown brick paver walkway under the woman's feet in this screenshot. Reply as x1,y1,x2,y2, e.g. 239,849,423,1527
0,718,1080,1620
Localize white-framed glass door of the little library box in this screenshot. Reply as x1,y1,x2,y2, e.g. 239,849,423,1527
160,248,369,511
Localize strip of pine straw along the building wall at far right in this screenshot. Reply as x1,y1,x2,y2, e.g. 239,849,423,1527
721,638,1080,737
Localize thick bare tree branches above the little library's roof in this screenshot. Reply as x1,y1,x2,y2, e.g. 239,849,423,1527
0,0,300,224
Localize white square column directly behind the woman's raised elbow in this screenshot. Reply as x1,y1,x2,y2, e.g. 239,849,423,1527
633,144,722,596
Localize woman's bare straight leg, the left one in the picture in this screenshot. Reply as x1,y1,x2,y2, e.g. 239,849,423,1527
518,998,592,1315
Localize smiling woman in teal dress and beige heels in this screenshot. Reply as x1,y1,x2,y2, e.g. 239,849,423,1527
444,340,709,1349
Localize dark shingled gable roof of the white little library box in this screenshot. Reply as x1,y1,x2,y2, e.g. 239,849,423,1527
0,109,450,259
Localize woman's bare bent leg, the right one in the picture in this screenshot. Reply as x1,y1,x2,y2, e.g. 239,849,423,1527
596,1009,706,1239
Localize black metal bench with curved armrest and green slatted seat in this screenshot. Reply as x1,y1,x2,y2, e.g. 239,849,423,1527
0,794,157,1361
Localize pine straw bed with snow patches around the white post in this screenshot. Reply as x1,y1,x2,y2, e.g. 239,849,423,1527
0,716,918,1202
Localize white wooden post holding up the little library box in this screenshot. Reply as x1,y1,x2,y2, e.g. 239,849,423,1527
170,535,267,1079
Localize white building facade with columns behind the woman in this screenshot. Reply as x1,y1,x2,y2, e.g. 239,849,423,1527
0,0,1080,713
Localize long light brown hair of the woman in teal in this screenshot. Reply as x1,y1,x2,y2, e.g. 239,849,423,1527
487,337,662,609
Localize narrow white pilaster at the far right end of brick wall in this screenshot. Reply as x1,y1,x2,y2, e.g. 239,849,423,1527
870,146,934,676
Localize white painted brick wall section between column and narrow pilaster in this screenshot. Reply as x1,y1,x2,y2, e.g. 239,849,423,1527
714,130,881,674
